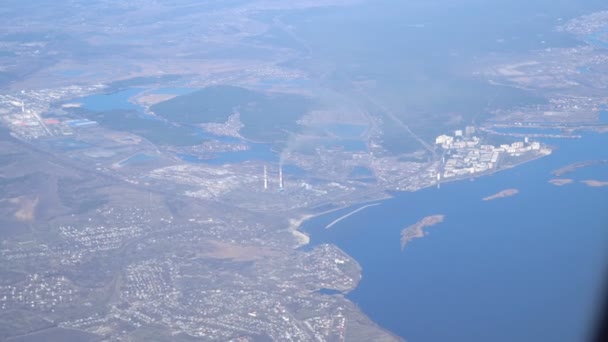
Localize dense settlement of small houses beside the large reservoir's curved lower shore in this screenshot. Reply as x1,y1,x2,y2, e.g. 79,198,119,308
55,245,355,341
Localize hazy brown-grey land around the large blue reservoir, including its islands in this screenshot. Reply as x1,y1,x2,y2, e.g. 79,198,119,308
0,0,608,341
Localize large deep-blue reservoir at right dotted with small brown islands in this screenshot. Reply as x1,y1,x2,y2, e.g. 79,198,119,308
303,134,608,342
